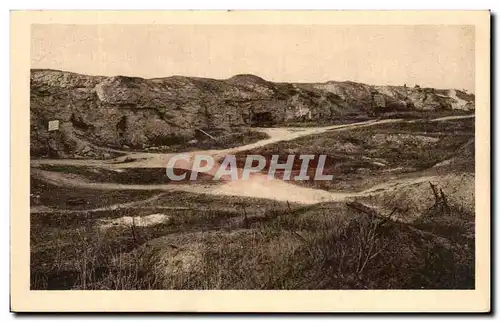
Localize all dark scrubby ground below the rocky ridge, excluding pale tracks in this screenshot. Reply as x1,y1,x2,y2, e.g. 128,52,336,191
30,119,475,290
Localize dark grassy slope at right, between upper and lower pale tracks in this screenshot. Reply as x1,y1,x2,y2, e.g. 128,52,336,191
238,119,474,191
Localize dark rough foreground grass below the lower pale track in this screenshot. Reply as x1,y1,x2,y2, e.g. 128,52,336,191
31,182,474,289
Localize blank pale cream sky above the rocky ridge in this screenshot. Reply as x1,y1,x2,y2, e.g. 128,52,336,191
31,24,475,92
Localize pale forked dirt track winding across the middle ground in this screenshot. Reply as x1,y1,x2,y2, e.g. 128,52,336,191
31,115,474,205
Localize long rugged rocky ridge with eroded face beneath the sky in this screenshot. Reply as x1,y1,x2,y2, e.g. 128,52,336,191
30,70,474,158
